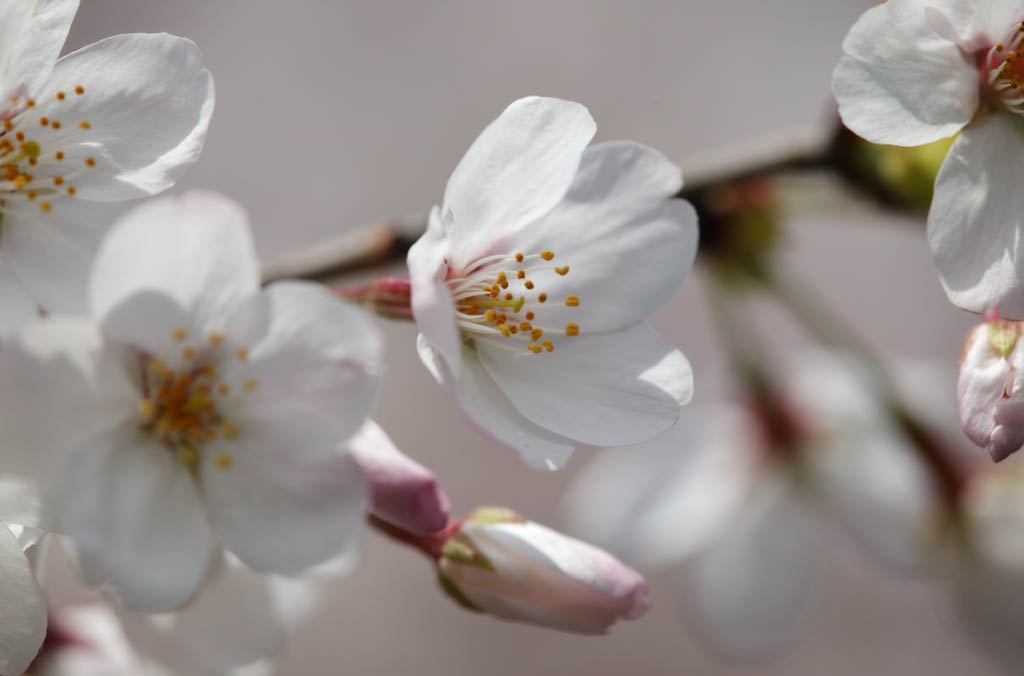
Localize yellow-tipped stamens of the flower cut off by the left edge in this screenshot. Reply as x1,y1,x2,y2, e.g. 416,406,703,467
0,85,96,215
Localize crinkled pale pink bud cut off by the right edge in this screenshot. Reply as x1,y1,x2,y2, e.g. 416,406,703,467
956,318,1024,462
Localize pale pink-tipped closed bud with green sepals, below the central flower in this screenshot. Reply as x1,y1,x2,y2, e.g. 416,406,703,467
438,508,650,634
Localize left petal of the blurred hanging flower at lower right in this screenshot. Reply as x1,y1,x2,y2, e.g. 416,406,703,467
564,406,761,566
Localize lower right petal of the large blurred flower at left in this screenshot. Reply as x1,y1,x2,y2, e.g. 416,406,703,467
200,438,369,576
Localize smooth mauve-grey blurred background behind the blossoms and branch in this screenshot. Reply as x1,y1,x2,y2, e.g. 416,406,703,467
54,0,1001,676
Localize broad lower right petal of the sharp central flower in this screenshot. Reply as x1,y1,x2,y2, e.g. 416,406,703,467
476,325,693,446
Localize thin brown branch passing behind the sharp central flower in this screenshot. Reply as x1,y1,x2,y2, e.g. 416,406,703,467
263,125,835,284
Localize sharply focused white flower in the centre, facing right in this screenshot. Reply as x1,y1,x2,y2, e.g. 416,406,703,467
409,97,697,469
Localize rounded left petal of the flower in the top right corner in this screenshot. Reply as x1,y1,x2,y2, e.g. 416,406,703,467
833,0,979,145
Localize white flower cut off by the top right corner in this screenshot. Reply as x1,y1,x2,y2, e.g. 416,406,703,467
833,0,1024,319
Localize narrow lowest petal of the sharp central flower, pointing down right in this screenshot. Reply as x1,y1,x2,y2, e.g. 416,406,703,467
416,335,573,470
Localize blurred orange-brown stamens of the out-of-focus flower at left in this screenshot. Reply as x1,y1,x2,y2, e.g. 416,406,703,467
138,329,259,475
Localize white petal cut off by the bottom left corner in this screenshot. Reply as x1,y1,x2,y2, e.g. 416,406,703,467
0,523,46,676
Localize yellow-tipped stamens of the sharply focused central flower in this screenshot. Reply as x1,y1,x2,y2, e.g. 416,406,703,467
447,251,580,354
